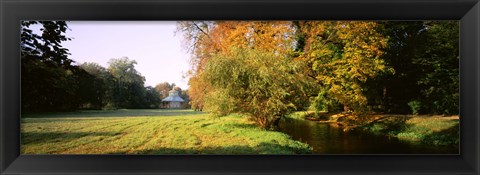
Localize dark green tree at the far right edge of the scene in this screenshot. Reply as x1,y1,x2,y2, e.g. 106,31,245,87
413,21,460,115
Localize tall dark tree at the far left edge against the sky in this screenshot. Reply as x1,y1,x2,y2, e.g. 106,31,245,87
20,21,79,111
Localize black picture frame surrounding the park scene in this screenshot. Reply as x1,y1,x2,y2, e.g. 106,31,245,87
0,0,480,174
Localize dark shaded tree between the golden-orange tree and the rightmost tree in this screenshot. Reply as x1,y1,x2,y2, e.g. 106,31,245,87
374,21,428,114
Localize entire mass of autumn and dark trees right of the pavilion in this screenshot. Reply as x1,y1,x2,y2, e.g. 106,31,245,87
177,21,459,128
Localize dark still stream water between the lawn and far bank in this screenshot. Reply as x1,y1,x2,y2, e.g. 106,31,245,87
279,118,459,154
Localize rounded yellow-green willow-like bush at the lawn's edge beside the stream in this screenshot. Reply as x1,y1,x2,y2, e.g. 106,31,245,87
199,49,312,129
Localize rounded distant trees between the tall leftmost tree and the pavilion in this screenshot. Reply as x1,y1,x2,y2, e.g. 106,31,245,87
79,57,161,109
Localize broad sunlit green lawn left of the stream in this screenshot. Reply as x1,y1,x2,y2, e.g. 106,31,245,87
21,110,312,154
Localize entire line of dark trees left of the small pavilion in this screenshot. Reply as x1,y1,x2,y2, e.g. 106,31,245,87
21,21,185,112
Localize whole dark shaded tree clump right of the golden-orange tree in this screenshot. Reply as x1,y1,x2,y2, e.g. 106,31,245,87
376,21,459,114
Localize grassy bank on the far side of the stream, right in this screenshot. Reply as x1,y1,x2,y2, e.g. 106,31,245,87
292,112,460,146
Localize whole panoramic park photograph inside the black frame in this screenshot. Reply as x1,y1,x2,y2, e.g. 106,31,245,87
20,21,460,155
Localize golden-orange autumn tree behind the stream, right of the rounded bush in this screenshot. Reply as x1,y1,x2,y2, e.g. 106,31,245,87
297,21,393,112
